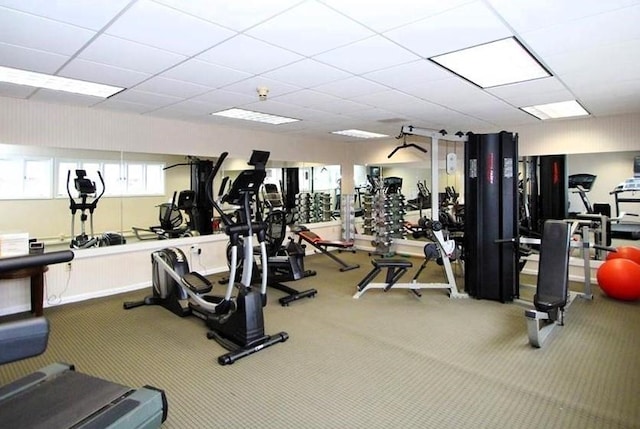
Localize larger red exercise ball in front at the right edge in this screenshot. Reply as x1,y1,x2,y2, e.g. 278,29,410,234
597,258,640,301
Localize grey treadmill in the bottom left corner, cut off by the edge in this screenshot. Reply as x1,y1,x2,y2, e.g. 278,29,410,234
0,250,167,429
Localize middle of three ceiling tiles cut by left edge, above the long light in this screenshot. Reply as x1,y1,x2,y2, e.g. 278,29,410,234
0,7,96,55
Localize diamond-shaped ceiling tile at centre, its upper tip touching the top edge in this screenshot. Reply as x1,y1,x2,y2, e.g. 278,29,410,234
247,1,374,56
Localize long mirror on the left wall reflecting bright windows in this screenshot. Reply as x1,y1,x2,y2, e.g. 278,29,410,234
0,144,340,251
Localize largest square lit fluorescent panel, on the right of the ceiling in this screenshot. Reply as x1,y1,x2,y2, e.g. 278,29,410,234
429,37,551,88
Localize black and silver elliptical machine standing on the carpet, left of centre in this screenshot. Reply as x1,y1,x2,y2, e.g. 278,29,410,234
123,150,289,365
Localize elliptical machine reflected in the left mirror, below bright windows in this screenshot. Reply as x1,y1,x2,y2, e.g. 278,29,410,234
67,170,106,249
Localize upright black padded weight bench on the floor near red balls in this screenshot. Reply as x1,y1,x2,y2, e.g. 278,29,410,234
524,220,571,347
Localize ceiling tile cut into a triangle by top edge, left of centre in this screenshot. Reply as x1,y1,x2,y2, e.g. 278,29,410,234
155,0,301,31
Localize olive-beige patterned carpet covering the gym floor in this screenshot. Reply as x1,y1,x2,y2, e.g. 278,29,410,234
0,249,640,429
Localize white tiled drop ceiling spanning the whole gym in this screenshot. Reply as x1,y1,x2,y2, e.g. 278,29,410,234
0,0,640,141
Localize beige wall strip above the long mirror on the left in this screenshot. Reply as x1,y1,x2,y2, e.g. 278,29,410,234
0,97,346,164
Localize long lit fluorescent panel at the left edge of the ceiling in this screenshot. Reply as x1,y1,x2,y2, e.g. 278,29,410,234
0,67,124,98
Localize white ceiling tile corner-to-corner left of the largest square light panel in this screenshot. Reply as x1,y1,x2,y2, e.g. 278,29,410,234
314,36,420,74
